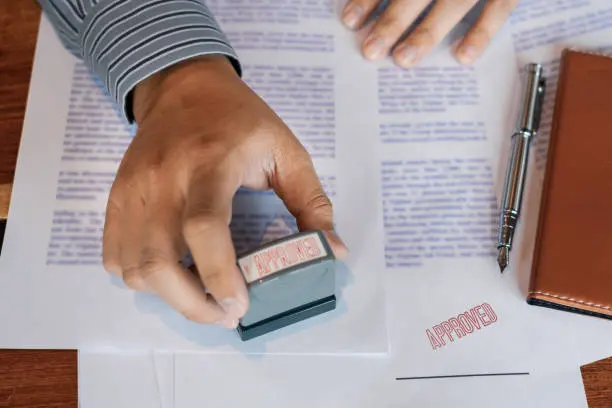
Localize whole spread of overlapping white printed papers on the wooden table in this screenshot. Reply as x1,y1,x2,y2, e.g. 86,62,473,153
0,0,612,408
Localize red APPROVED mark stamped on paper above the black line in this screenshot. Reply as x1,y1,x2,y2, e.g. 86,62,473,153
425,303,497,350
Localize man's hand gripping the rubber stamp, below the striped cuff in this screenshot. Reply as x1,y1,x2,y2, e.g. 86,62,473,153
103,56,346,327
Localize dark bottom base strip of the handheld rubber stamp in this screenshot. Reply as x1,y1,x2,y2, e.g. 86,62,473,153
236,295,336,341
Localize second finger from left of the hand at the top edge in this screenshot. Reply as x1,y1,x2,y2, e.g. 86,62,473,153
362,0,430,60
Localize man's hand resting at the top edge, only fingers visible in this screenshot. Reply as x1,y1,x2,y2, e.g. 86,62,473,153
342,0,519,68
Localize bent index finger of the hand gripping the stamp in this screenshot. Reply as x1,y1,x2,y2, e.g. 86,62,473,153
183,170,249,327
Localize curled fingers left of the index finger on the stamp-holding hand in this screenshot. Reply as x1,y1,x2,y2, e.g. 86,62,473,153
103,185,235,327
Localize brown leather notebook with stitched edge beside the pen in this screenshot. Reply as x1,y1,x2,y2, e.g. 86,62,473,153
527,50,612,319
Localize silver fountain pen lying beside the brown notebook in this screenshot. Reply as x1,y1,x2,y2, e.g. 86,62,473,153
497,63,546,273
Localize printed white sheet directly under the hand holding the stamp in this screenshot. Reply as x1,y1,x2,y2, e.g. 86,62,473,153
0,10,388,354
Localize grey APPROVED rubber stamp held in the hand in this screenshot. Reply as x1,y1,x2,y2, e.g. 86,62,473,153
237,231,336,341
